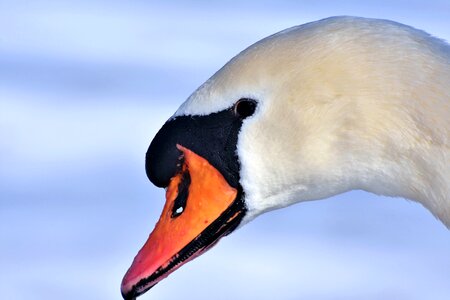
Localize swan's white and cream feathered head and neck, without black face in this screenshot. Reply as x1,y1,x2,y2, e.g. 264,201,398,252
175,17,450,226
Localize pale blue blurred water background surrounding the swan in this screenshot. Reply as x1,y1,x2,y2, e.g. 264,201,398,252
0,0,450,300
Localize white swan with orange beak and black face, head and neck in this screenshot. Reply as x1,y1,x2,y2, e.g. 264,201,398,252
121,17,450,299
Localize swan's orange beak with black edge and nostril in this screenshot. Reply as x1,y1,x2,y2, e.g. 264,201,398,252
121,145,242,299
